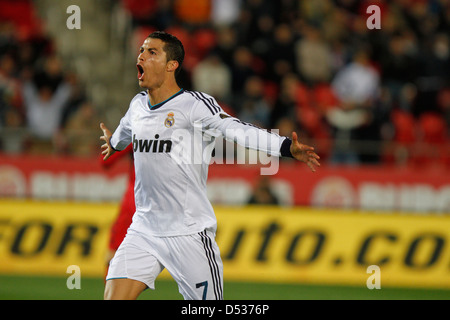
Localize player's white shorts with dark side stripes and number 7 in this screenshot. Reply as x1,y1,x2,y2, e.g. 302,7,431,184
106,230,223,300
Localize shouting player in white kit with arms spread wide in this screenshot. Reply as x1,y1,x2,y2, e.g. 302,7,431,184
100,31,320,300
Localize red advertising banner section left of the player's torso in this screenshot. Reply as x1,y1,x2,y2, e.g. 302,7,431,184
0,155,130,201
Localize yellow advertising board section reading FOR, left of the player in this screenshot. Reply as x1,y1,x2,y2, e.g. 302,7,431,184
0,200,119,275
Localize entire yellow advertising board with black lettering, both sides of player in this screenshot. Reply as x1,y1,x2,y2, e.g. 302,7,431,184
0,200,450,288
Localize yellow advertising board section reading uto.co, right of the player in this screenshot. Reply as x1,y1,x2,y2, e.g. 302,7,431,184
216,207,450,288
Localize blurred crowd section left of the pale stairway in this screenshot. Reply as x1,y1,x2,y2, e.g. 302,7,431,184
0,0,98,155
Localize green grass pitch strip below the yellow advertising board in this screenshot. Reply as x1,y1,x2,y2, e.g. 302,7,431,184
0,275,450,300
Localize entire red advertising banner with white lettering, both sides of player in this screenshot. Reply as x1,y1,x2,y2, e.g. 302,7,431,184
0,155,450,213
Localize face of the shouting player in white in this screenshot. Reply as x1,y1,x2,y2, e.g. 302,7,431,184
136,38,168,89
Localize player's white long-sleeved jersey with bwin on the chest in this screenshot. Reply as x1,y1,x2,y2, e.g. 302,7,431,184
110,89,289,236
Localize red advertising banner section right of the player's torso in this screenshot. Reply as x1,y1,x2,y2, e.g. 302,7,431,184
208,163,450,213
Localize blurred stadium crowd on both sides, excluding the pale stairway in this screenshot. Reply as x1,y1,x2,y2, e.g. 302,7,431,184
0,0,450,166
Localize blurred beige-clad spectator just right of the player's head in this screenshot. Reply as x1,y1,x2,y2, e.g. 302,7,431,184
192,54,231,101
